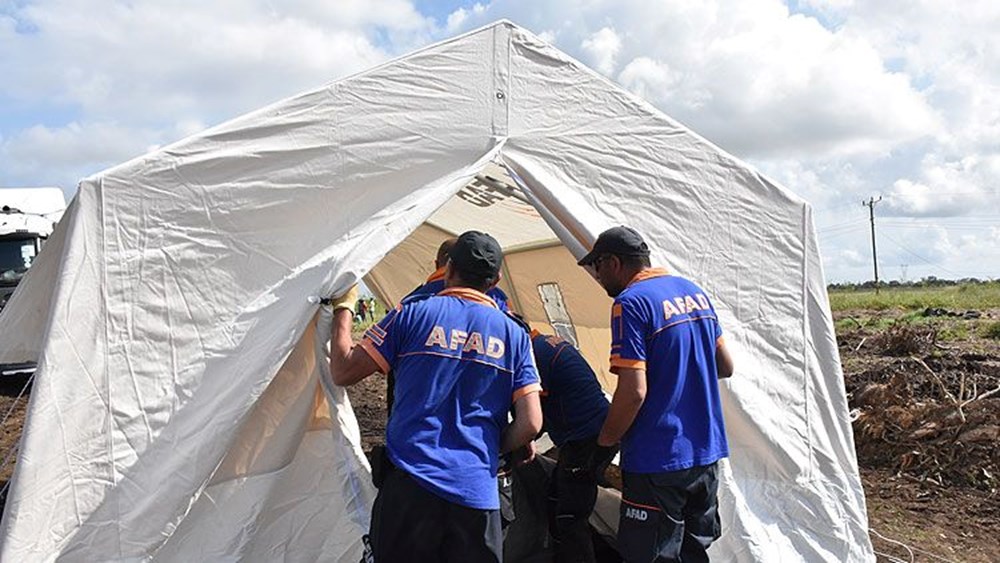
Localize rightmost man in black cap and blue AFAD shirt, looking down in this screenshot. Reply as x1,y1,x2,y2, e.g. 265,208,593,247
579,226,733,562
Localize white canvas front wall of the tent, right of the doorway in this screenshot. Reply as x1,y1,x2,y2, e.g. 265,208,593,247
503,26,870,560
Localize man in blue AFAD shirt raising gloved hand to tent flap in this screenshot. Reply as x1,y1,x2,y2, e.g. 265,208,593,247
330,231,542,562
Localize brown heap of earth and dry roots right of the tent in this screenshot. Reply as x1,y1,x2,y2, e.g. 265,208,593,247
841,325,1000,492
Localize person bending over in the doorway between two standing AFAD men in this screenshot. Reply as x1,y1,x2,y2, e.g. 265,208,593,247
531,331,617,563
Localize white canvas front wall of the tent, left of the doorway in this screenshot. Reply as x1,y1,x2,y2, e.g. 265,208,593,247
0,25,502,561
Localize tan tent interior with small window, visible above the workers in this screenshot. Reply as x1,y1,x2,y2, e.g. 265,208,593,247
364,162,614,390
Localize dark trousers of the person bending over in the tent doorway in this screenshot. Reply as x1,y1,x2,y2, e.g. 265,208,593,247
549,437,597,563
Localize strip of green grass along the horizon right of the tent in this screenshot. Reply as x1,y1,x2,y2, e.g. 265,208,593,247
830,282,1000,311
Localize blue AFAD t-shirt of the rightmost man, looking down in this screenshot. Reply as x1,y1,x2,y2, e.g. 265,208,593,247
611,268,729,473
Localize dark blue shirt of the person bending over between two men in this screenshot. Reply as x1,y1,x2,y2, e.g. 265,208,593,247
531,332,608,446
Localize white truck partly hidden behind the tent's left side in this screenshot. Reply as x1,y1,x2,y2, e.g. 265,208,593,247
0,188,66,375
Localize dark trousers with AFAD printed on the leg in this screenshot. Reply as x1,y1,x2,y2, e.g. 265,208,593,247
618,463,722,563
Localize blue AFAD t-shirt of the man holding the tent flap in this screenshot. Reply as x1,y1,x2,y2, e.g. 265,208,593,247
361,288,540,510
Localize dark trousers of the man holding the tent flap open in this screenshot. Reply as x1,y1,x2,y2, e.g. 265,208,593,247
369,468,503,563
